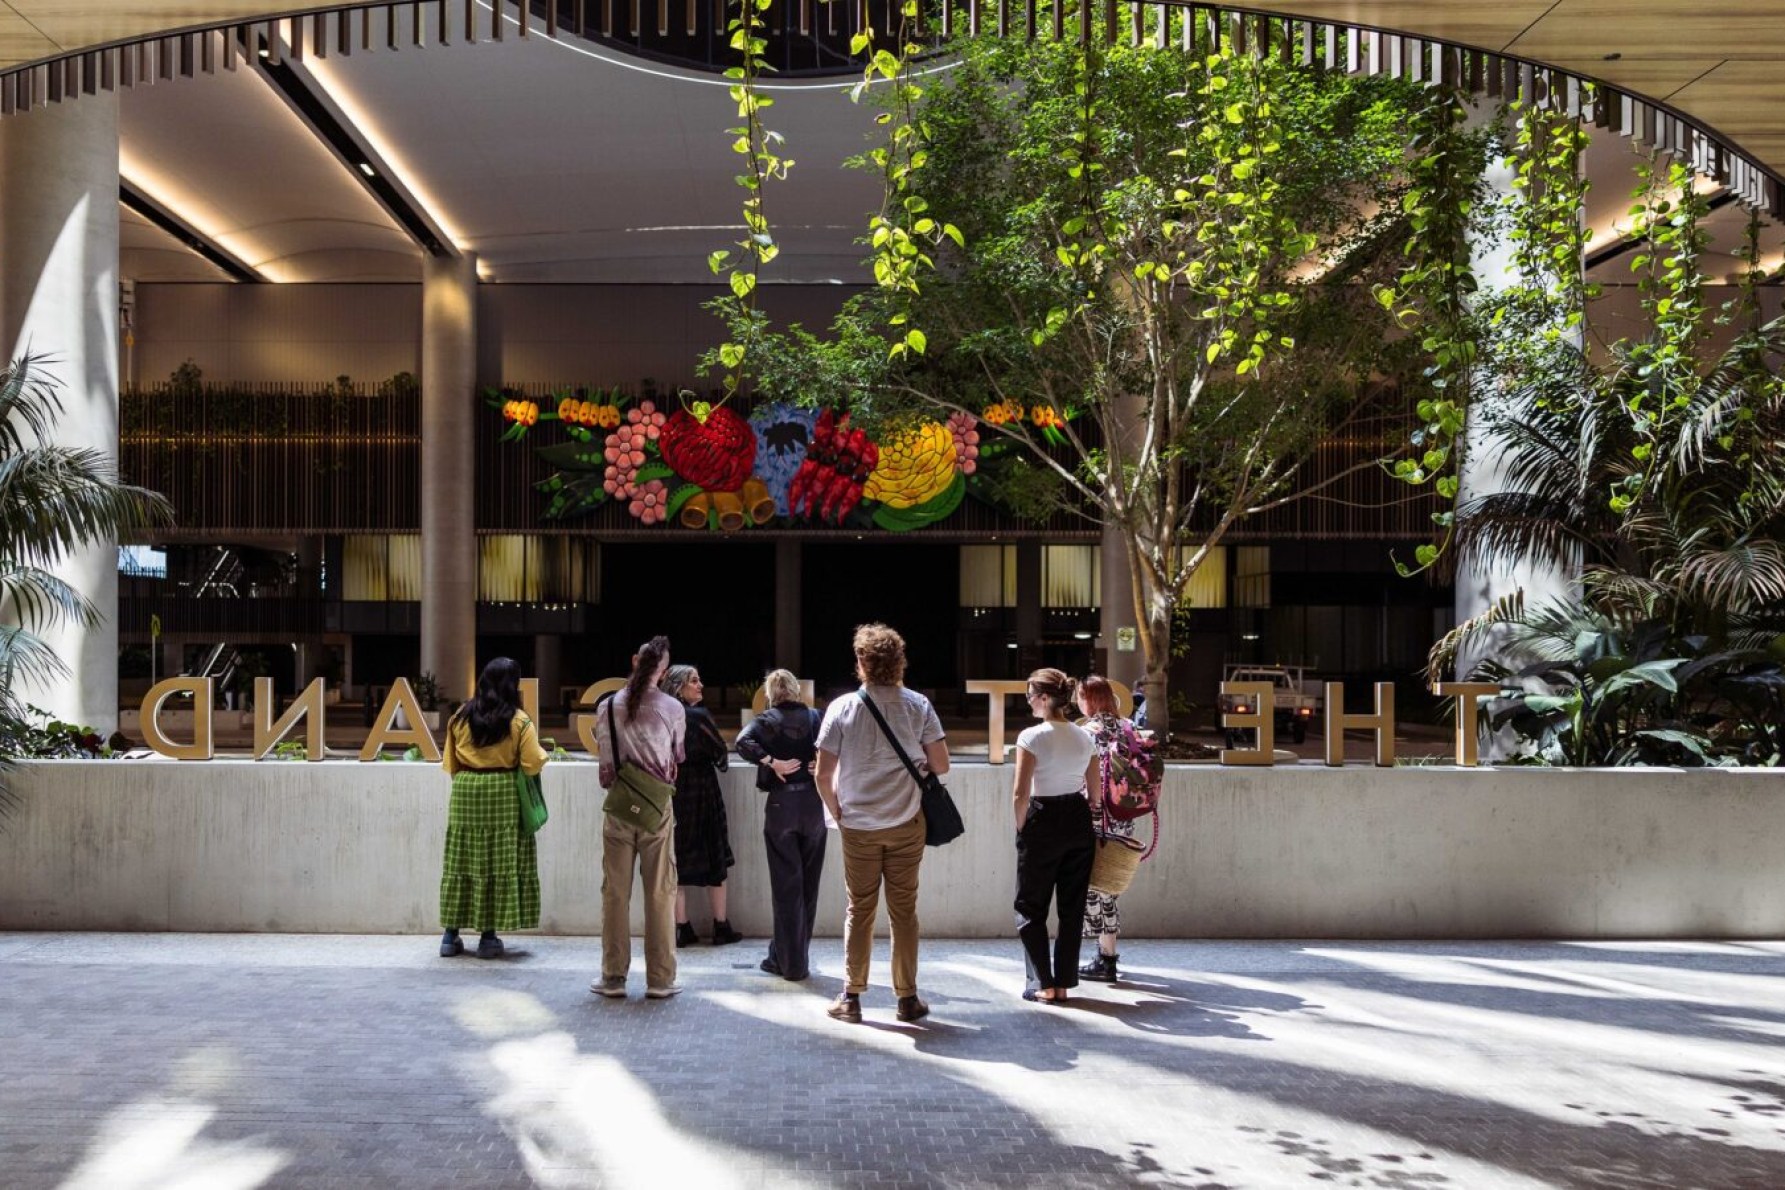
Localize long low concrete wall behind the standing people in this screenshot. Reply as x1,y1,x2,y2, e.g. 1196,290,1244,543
0,760,1785,938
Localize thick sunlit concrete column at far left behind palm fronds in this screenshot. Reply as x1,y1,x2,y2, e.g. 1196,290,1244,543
0,95,118,733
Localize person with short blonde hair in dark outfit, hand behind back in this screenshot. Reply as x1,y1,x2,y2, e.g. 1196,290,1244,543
737,669,826,981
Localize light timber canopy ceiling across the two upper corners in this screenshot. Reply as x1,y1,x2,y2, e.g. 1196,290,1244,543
10,0,1785,177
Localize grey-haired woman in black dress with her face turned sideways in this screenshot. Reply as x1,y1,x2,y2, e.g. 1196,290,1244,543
660,665,744,947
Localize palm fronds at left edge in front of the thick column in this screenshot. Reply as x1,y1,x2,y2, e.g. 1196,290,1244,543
0,353,173,808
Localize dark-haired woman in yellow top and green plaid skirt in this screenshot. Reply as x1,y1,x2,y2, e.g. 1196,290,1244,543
441,657,546,958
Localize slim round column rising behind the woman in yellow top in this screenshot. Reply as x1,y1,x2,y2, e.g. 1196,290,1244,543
421,253,478,701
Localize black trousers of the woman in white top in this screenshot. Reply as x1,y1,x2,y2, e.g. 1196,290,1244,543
1016,797,1096,990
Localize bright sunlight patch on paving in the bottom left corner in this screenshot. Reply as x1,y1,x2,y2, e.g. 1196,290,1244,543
62,1097,291,1190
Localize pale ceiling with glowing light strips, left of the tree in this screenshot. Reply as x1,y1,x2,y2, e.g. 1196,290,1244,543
113,24,880,285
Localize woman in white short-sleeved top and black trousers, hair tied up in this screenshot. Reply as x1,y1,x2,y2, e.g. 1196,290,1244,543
1014,669,1103,1004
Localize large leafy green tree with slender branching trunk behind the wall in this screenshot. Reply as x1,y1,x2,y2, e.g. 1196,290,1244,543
738,30,1417,730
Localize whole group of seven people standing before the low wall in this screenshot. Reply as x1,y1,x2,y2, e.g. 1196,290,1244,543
441,624,1149,1022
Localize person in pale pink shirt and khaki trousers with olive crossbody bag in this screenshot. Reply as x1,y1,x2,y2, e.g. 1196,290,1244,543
589,637,687,999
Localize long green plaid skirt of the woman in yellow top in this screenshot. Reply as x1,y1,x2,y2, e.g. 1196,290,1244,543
441,773,539,931
